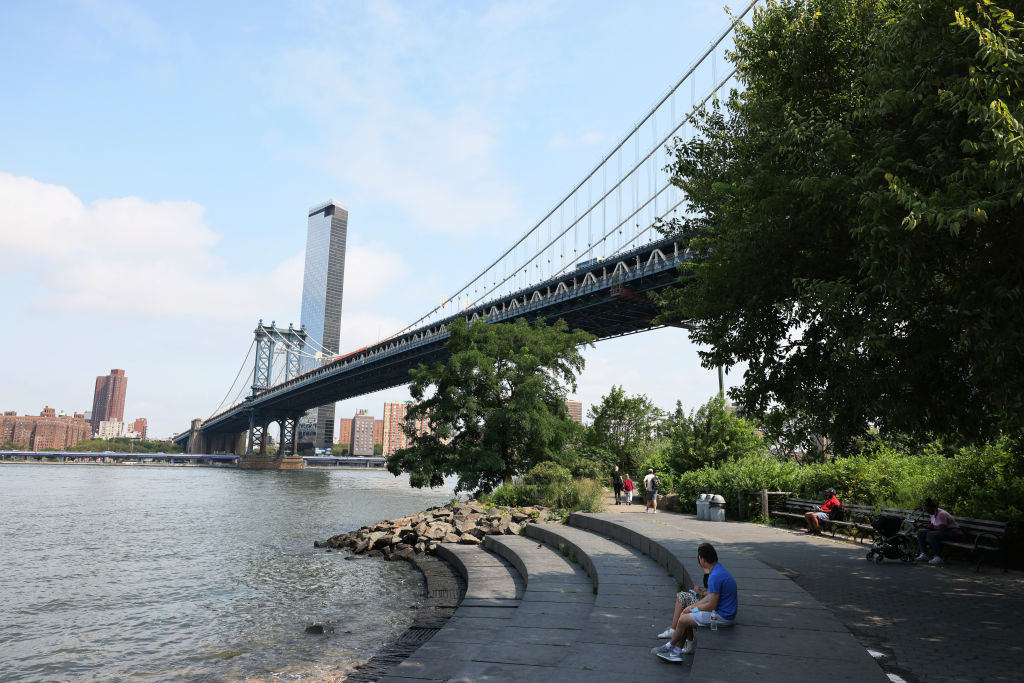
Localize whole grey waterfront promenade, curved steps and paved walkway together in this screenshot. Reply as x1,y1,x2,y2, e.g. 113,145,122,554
381,505,1024,681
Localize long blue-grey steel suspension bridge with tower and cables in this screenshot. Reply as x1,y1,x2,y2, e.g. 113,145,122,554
174,0,758,468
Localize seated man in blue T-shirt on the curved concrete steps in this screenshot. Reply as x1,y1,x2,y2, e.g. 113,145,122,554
651,543,739,661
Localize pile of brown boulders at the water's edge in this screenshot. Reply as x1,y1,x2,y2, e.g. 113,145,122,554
313,501,551,560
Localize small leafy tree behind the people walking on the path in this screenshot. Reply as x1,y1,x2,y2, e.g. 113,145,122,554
587,386,664,472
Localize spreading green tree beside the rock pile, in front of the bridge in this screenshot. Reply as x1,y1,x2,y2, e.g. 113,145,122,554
387,318,594,493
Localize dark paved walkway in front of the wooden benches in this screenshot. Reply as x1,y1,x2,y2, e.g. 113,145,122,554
606,497,1024,683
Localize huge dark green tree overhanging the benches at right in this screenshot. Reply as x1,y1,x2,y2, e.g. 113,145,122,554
660,0,1024,446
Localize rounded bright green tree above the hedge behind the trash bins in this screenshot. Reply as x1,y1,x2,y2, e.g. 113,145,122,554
664,396,768,472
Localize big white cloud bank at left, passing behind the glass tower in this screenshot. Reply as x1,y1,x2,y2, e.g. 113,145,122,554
0,173,408,327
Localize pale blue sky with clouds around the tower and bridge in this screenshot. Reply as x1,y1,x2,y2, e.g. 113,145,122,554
0,0,740,438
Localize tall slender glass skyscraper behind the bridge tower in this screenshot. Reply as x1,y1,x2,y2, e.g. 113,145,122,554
296,200,348,449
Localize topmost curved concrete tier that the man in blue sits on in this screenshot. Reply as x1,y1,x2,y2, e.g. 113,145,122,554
569,513,888,682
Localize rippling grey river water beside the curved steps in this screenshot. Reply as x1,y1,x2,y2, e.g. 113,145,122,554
0,464,452,681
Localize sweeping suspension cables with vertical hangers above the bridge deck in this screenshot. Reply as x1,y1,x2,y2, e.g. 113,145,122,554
396,0,760,335
